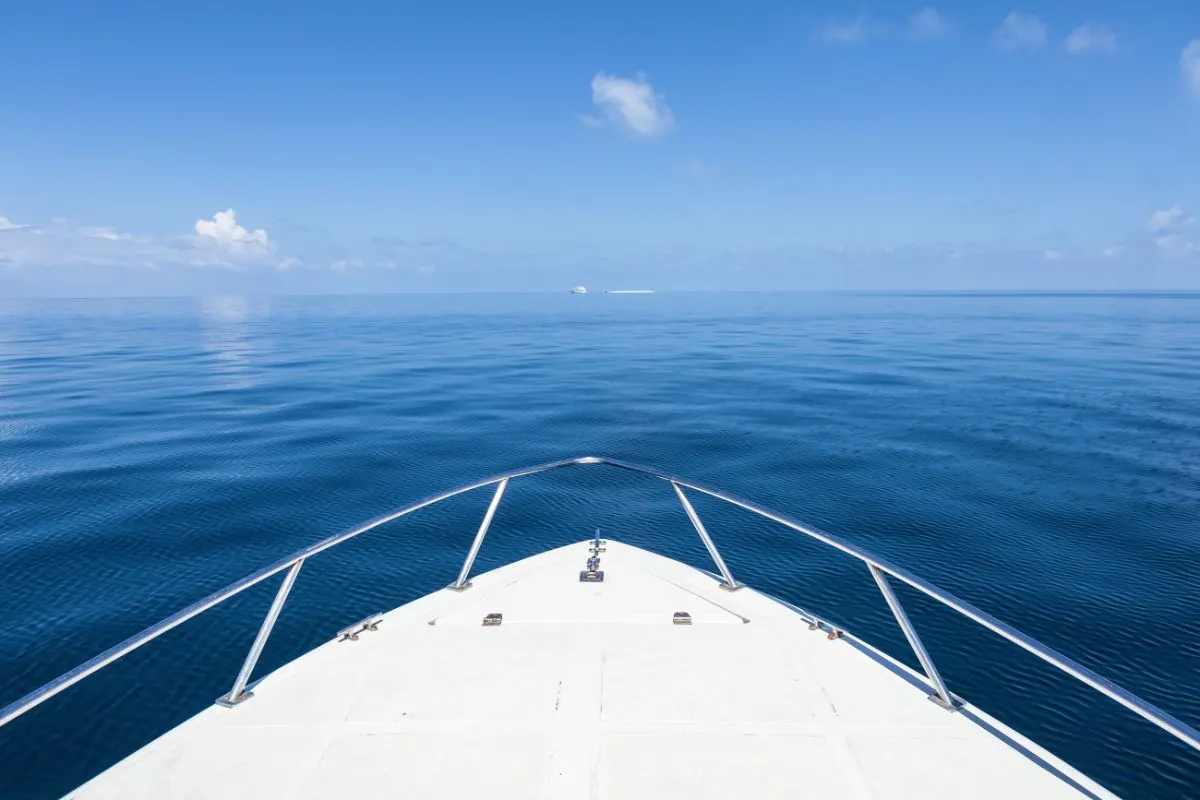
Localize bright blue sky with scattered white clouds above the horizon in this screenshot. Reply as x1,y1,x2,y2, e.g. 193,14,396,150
0,0,1200,296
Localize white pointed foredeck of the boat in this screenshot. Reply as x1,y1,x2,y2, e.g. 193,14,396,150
70,541,1112,800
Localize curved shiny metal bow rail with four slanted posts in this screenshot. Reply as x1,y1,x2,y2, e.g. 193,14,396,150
0,456,1200,751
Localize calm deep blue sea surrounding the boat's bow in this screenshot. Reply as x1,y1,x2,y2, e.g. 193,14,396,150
0,293,1200,798
